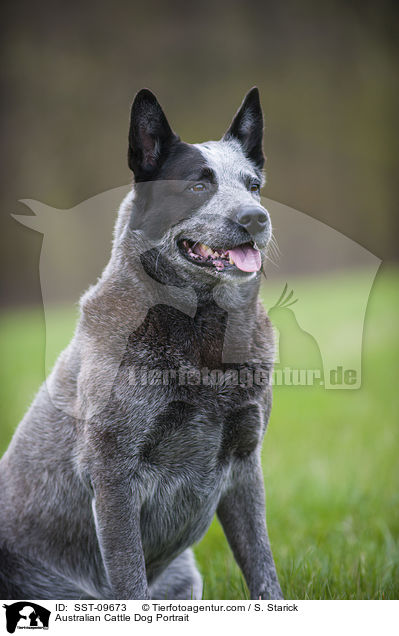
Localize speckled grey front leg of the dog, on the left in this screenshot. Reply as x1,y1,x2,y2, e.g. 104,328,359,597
92,474,150,599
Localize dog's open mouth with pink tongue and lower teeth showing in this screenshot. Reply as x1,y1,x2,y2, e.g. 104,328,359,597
179,239,262,272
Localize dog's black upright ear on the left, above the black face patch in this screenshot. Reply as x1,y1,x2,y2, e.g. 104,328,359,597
128,88,179,181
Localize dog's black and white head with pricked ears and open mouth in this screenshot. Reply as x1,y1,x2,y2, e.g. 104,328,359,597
128,88,271,286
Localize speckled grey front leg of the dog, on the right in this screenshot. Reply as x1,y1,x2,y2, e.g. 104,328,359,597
217,453,283,599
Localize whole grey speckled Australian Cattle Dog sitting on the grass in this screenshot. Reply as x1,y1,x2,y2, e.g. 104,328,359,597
0,88,282,599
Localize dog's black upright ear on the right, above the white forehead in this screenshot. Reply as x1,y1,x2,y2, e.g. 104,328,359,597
223,86,265,170
